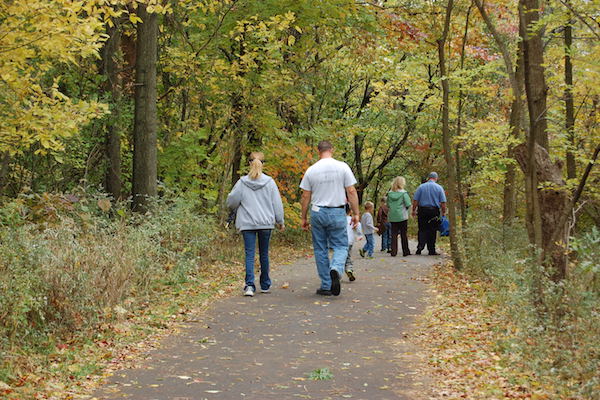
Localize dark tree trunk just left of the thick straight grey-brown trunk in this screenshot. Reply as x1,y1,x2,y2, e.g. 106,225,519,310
101,24,121,200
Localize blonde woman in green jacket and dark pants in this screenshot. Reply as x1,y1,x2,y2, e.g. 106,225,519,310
387,176,410,257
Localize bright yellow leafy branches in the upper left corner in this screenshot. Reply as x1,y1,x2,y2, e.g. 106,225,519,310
0,0,112,154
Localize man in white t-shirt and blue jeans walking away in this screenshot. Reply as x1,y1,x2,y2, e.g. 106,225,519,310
300,140,360,296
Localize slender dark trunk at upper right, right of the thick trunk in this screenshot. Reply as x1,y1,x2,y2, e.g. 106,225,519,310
564,7,577,179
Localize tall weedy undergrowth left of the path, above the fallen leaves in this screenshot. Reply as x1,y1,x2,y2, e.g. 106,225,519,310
0,194,218,349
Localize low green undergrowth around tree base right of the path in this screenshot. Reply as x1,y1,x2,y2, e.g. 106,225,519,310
465,218,600,398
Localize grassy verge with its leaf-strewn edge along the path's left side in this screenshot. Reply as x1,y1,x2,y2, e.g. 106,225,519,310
0,198,310,400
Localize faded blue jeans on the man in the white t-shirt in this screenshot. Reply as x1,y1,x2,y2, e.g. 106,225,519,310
310,208,348,290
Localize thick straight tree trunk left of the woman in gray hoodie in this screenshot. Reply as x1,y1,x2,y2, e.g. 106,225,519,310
132,4,158,212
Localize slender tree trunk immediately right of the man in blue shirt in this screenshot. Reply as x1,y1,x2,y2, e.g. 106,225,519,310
437,0,463,270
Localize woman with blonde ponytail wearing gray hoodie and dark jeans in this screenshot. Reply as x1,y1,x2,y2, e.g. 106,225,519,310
227,152,284,296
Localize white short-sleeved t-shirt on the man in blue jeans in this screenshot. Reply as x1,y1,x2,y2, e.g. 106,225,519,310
300,158,356,207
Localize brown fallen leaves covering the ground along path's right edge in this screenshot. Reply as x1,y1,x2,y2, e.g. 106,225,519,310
410,263,579,400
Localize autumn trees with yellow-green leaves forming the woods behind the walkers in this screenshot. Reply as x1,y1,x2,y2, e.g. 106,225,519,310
0,0,600,396
